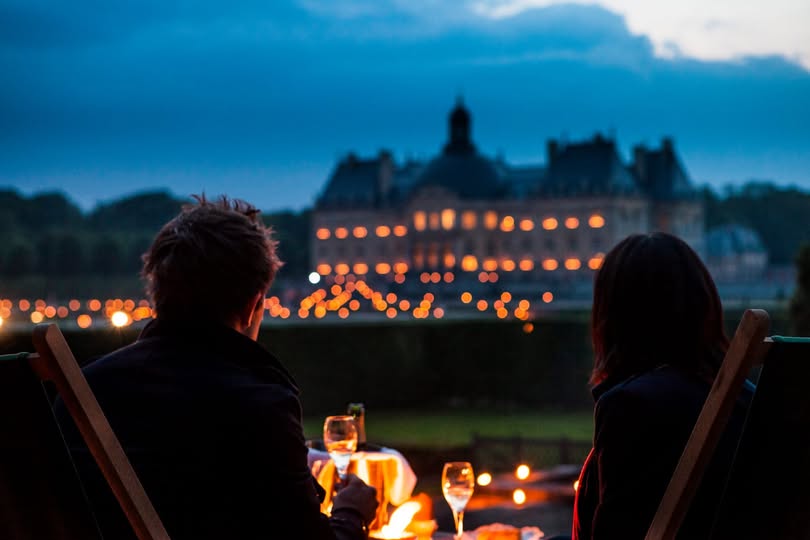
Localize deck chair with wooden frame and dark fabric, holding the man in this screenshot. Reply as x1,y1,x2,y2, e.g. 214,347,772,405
0,324,169,540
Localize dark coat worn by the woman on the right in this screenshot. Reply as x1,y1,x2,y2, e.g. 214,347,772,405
572,366,753,540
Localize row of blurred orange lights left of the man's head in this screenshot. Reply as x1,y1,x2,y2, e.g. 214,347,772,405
0,298,154,328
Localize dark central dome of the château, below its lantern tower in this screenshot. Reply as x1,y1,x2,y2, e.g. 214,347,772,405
417,153,502,199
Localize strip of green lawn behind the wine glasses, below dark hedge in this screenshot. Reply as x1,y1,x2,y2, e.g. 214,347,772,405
304,410,593,448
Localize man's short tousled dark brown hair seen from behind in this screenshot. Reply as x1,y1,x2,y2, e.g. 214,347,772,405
142,195,282,323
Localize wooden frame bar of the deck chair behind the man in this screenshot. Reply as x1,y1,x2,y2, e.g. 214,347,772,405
28,324,169,540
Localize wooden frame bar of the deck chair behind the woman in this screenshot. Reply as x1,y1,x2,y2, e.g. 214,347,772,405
645,309,772,540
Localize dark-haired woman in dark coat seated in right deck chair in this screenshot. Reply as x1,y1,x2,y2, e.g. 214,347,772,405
573,233,744,540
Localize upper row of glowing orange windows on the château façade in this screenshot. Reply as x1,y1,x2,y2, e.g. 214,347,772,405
315,208,605,240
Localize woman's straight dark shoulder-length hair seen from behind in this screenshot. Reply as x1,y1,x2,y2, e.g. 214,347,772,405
591,233,728,384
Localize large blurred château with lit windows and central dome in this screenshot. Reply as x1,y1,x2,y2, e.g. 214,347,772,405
311,100,704,296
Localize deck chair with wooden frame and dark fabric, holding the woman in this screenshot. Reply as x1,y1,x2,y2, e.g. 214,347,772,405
646,310,810,540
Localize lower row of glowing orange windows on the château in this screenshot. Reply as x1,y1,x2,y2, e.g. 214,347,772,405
310,253,605,283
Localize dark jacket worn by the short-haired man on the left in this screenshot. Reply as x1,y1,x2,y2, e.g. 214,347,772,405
55,320,364,540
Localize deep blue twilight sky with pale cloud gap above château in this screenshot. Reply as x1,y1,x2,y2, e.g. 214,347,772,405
0,0,810,210
